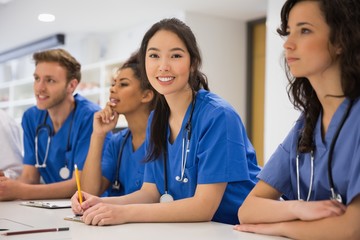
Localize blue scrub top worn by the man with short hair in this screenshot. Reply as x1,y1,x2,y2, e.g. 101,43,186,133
21,94,110,183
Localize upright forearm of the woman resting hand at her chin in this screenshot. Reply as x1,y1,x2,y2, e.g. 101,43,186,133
81,134,105,196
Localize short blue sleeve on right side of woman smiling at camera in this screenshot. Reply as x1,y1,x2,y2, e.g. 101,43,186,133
195,108,253,184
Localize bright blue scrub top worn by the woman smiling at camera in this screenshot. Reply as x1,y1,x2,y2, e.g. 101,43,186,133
144,90,259,224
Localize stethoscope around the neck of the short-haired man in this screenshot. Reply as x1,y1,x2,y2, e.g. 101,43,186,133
35,102,76,179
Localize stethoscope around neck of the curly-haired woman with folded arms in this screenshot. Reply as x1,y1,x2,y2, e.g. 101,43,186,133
296,100,353,203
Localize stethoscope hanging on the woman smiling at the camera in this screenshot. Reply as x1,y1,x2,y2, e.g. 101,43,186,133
160,93,196,203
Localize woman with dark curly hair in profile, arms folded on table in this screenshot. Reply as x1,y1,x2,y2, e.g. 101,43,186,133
235,0,360,239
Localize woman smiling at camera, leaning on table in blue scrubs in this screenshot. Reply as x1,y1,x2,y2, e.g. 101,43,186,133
72,19,259,225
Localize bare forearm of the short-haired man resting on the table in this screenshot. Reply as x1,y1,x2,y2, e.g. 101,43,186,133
19,179,76,200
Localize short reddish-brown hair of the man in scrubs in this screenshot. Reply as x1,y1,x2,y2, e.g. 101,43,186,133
33,48,81,82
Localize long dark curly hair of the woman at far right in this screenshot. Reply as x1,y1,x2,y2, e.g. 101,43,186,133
277,0,360,152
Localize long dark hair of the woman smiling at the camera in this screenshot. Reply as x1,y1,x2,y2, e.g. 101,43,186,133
139,18,209,162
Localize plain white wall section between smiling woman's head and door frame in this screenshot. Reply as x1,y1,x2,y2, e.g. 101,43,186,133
185,13,246,119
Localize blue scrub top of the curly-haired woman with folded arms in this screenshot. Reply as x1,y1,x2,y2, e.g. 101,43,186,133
258,99,360,204
